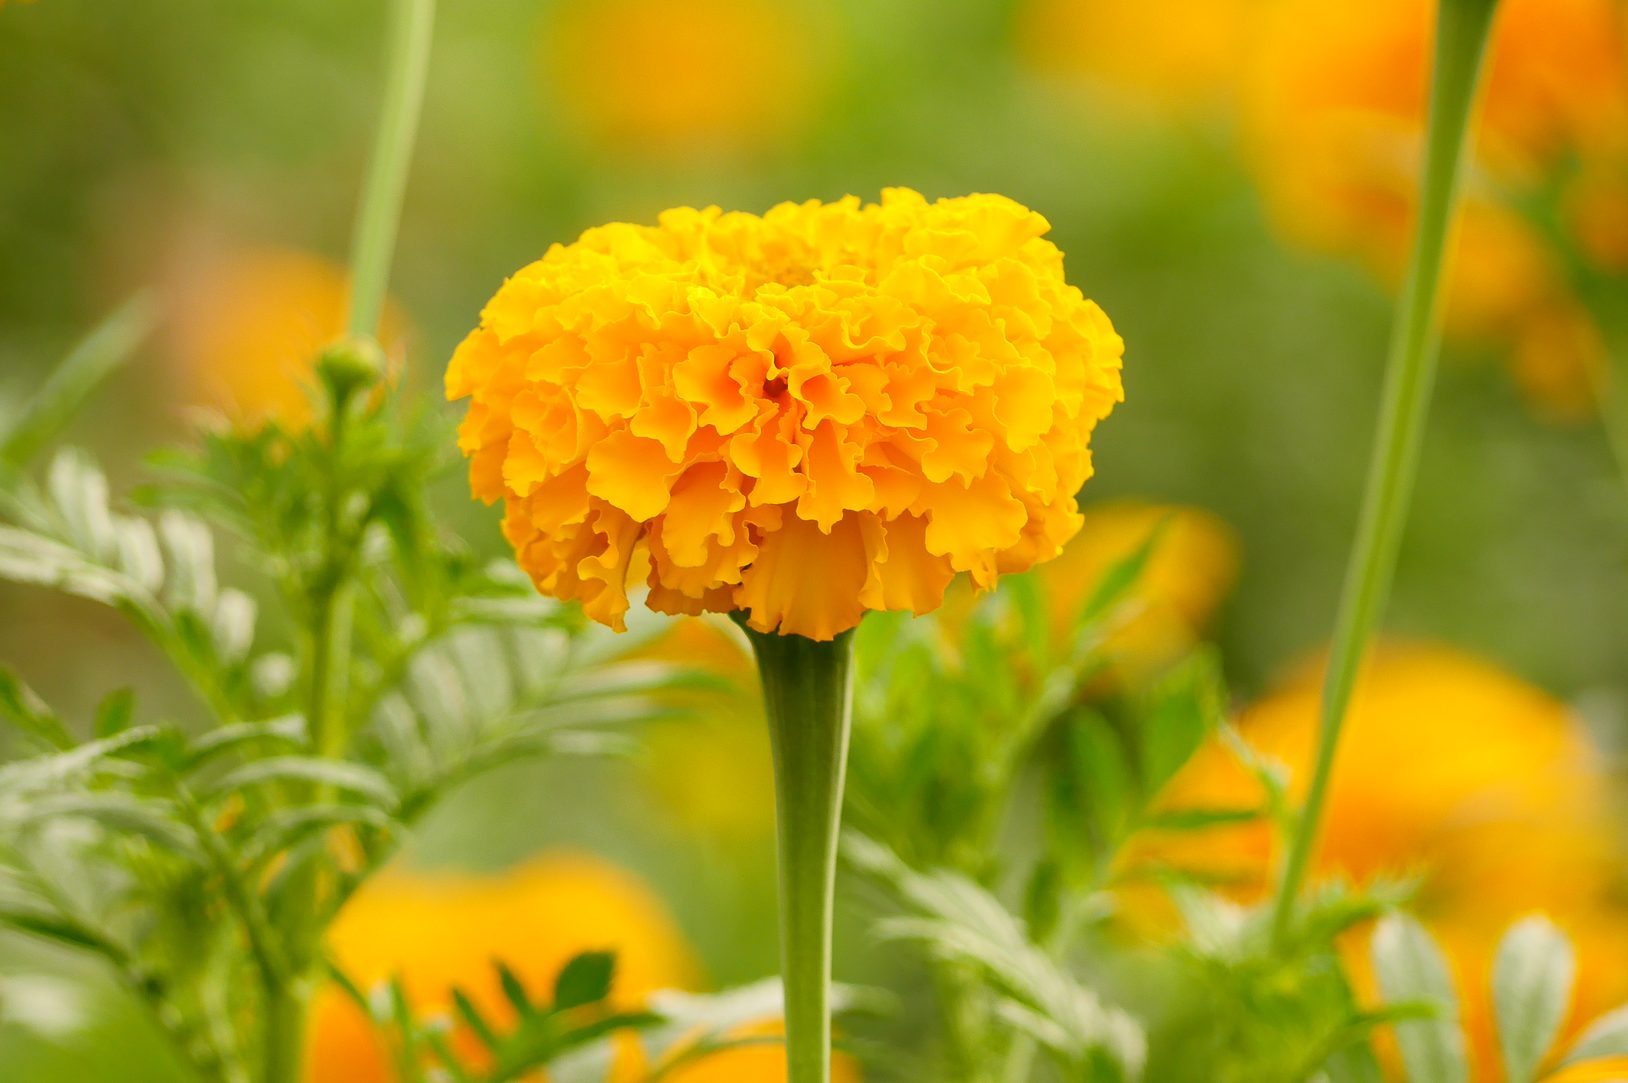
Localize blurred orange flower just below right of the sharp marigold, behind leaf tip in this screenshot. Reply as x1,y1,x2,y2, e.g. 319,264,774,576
1039,500,1237,682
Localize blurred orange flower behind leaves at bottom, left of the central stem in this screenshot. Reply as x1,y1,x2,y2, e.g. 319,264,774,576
306,853,858,1083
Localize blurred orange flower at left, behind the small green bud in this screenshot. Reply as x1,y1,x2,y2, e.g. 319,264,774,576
166,246,404,427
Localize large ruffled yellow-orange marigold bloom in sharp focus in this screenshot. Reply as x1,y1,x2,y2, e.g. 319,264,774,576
446,189,1123,640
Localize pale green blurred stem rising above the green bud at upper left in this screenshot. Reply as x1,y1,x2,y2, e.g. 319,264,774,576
347,0,435,339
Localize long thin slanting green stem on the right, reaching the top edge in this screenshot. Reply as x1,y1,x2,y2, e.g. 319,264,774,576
1273,0,1498,943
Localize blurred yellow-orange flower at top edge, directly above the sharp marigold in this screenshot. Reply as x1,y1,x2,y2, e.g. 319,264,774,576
539,0,830,153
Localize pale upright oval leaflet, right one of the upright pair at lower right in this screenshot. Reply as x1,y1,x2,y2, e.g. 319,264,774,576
1493,917,1576,1083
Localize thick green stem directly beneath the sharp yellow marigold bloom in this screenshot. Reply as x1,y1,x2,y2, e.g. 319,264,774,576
747,630,853,1083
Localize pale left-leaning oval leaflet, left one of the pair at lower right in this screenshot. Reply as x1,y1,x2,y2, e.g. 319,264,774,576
1371,914,1470,1083
